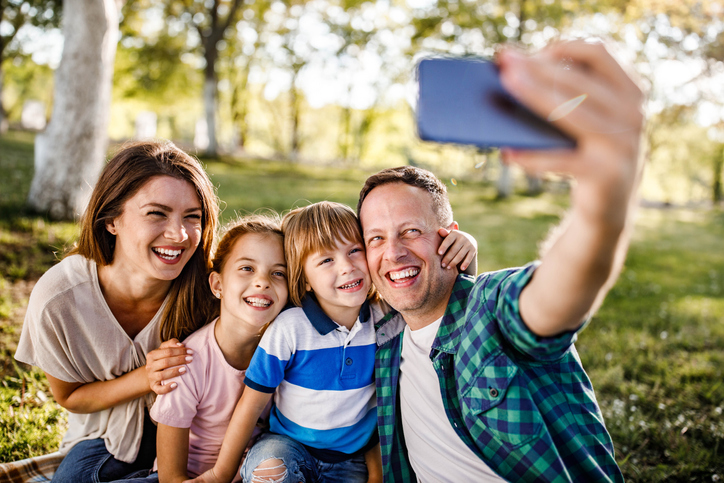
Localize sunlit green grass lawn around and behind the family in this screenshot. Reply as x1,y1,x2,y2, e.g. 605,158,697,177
0,132,724,482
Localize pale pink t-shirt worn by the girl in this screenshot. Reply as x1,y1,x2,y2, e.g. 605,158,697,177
151,319,268,482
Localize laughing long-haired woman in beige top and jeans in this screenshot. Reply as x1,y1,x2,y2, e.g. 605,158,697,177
15,142,218,483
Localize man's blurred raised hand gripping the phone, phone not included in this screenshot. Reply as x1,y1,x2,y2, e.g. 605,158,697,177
498,41,644,219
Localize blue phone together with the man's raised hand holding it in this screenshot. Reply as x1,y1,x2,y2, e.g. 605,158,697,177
417,41,643,220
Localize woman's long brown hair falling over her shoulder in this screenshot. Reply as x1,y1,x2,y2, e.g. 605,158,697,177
69,141,219,340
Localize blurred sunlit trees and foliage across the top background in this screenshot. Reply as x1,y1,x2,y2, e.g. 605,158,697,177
0,0,724,217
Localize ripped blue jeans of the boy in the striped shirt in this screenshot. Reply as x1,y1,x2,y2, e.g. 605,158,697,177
241,433,367,483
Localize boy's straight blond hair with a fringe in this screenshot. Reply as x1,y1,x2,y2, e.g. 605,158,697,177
282,201,377,307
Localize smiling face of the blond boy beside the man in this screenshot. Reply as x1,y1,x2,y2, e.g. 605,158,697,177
304,240,371,328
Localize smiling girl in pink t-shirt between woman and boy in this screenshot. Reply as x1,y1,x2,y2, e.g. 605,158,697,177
114,215,288,483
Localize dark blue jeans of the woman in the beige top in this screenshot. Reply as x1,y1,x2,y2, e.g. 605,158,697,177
52,412,156,483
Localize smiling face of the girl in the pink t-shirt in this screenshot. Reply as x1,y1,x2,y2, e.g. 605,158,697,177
209,233,288,329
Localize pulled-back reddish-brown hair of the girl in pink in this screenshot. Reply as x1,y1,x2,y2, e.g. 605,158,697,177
211,210,284,318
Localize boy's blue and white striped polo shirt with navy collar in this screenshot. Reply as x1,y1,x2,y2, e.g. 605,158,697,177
244,295,383,459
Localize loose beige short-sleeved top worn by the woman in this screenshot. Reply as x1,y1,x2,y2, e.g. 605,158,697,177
15,255,166,463
